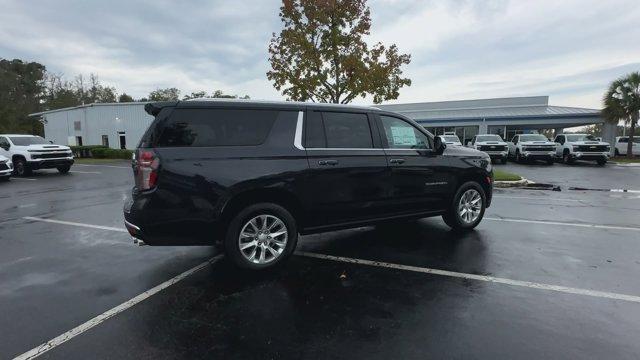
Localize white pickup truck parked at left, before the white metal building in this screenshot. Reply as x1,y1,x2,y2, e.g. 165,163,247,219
0,134,73,176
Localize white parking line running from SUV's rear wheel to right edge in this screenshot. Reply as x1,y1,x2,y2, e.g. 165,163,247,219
296,251,640,303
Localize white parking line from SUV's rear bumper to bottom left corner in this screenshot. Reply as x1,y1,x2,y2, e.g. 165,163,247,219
14,255,222,360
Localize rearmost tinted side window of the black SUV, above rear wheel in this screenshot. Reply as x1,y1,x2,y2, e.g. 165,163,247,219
156,109,278,147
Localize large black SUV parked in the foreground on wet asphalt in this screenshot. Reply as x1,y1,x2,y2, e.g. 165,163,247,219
124,100,493,269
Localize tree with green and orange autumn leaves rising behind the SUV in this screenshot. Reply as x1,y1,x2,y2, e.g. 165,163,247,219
267,0,411,104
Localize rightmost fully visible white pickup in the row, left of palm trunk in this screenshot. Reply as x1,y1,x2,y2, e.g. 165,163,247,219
555,134,611,166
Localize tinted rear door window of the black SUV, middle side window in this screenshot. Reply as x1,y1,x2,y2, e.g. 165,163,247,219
322,112,373,148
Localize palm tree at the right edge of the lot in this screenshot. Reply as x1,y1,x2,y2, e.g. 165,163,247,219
602,72,640,158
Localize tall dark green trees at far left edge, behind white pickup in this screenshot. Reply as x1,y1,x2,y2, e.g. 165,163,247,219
0,59,46,135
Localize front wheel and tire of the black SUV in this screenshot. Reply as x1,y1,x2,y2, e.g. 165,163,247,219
442,181,487,231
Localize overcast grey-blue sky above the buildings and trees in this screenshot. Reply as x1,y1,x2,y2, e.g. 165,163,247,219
0,0,640,108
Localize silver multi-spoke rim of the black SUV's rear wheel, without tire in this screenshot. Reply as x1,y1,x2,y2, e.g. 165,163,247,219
238,214,289,265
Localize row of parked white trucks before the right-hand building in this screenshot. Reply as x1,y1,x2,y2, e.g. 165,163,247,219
439,134,628,165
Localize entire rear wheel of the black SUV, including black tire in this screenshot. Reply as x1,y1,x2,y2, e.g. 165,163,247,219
224,203,298,270
